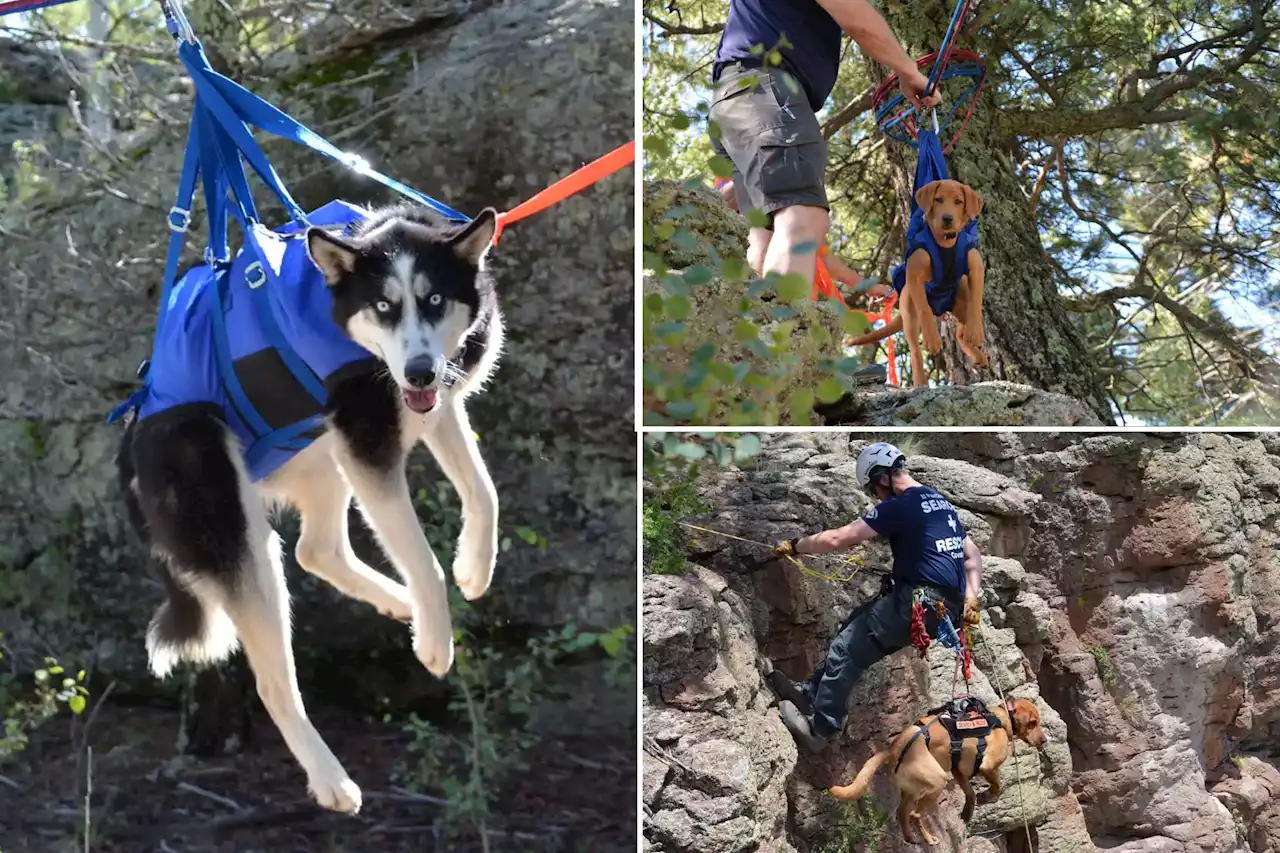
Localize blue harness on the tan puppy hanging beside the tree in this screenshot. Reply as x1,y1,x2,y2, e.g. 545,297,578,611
892,129,978,316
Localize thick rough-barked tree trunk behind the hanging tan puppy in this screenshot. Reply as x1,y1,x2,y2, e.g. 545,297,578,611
873,0,1114,424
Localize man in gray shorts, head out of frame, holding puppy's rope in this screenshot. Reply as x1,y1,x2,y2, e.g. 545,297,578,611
710,0,940,284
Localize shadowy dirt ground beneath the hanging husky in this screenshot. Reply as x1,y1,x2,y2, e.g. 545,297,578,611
0,704,636,853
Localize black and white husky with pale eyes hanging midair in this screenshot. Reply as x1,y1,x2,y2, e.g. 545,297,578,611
118,207,503,812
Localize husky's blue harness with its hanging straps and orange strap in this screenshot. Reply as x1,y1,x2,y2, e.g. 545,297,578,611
92,0,635,480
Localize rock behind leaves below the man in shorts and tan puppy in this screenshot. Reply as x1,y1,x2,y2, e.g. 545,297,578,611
644,181,1101,427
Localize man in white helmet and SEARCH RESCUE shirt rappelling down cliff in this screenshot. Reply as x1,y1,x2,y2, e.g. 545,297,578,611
773,442,982,752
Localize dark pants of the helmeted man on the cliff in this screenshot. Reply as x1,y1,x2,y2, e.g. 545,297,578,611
804,583,964,738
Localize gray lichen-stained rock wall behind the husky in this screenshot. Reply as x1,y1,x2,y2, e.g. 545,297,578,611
0,0,636,717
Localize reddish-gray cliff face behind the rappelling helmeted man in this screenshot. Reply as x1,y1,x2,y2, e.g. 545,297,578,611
644,433,1280,853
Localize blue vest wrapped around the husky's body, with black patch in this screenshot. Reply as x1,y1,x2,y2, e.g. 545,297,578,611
111,201,376,480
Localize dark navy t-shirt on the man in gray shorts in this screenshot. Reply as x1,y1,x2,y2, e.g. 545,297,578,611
716,0,844,113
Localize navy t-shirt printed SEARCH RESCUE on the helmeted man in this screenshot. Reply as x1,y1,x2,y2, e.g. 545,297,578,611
863,485,965,597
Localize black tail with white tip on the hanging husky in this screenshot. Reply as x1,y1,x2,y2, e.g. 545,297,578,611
147,562,239,678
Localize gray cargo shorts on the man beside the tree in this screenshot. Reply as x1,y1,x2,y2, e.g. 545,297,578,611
709,64,829,227
